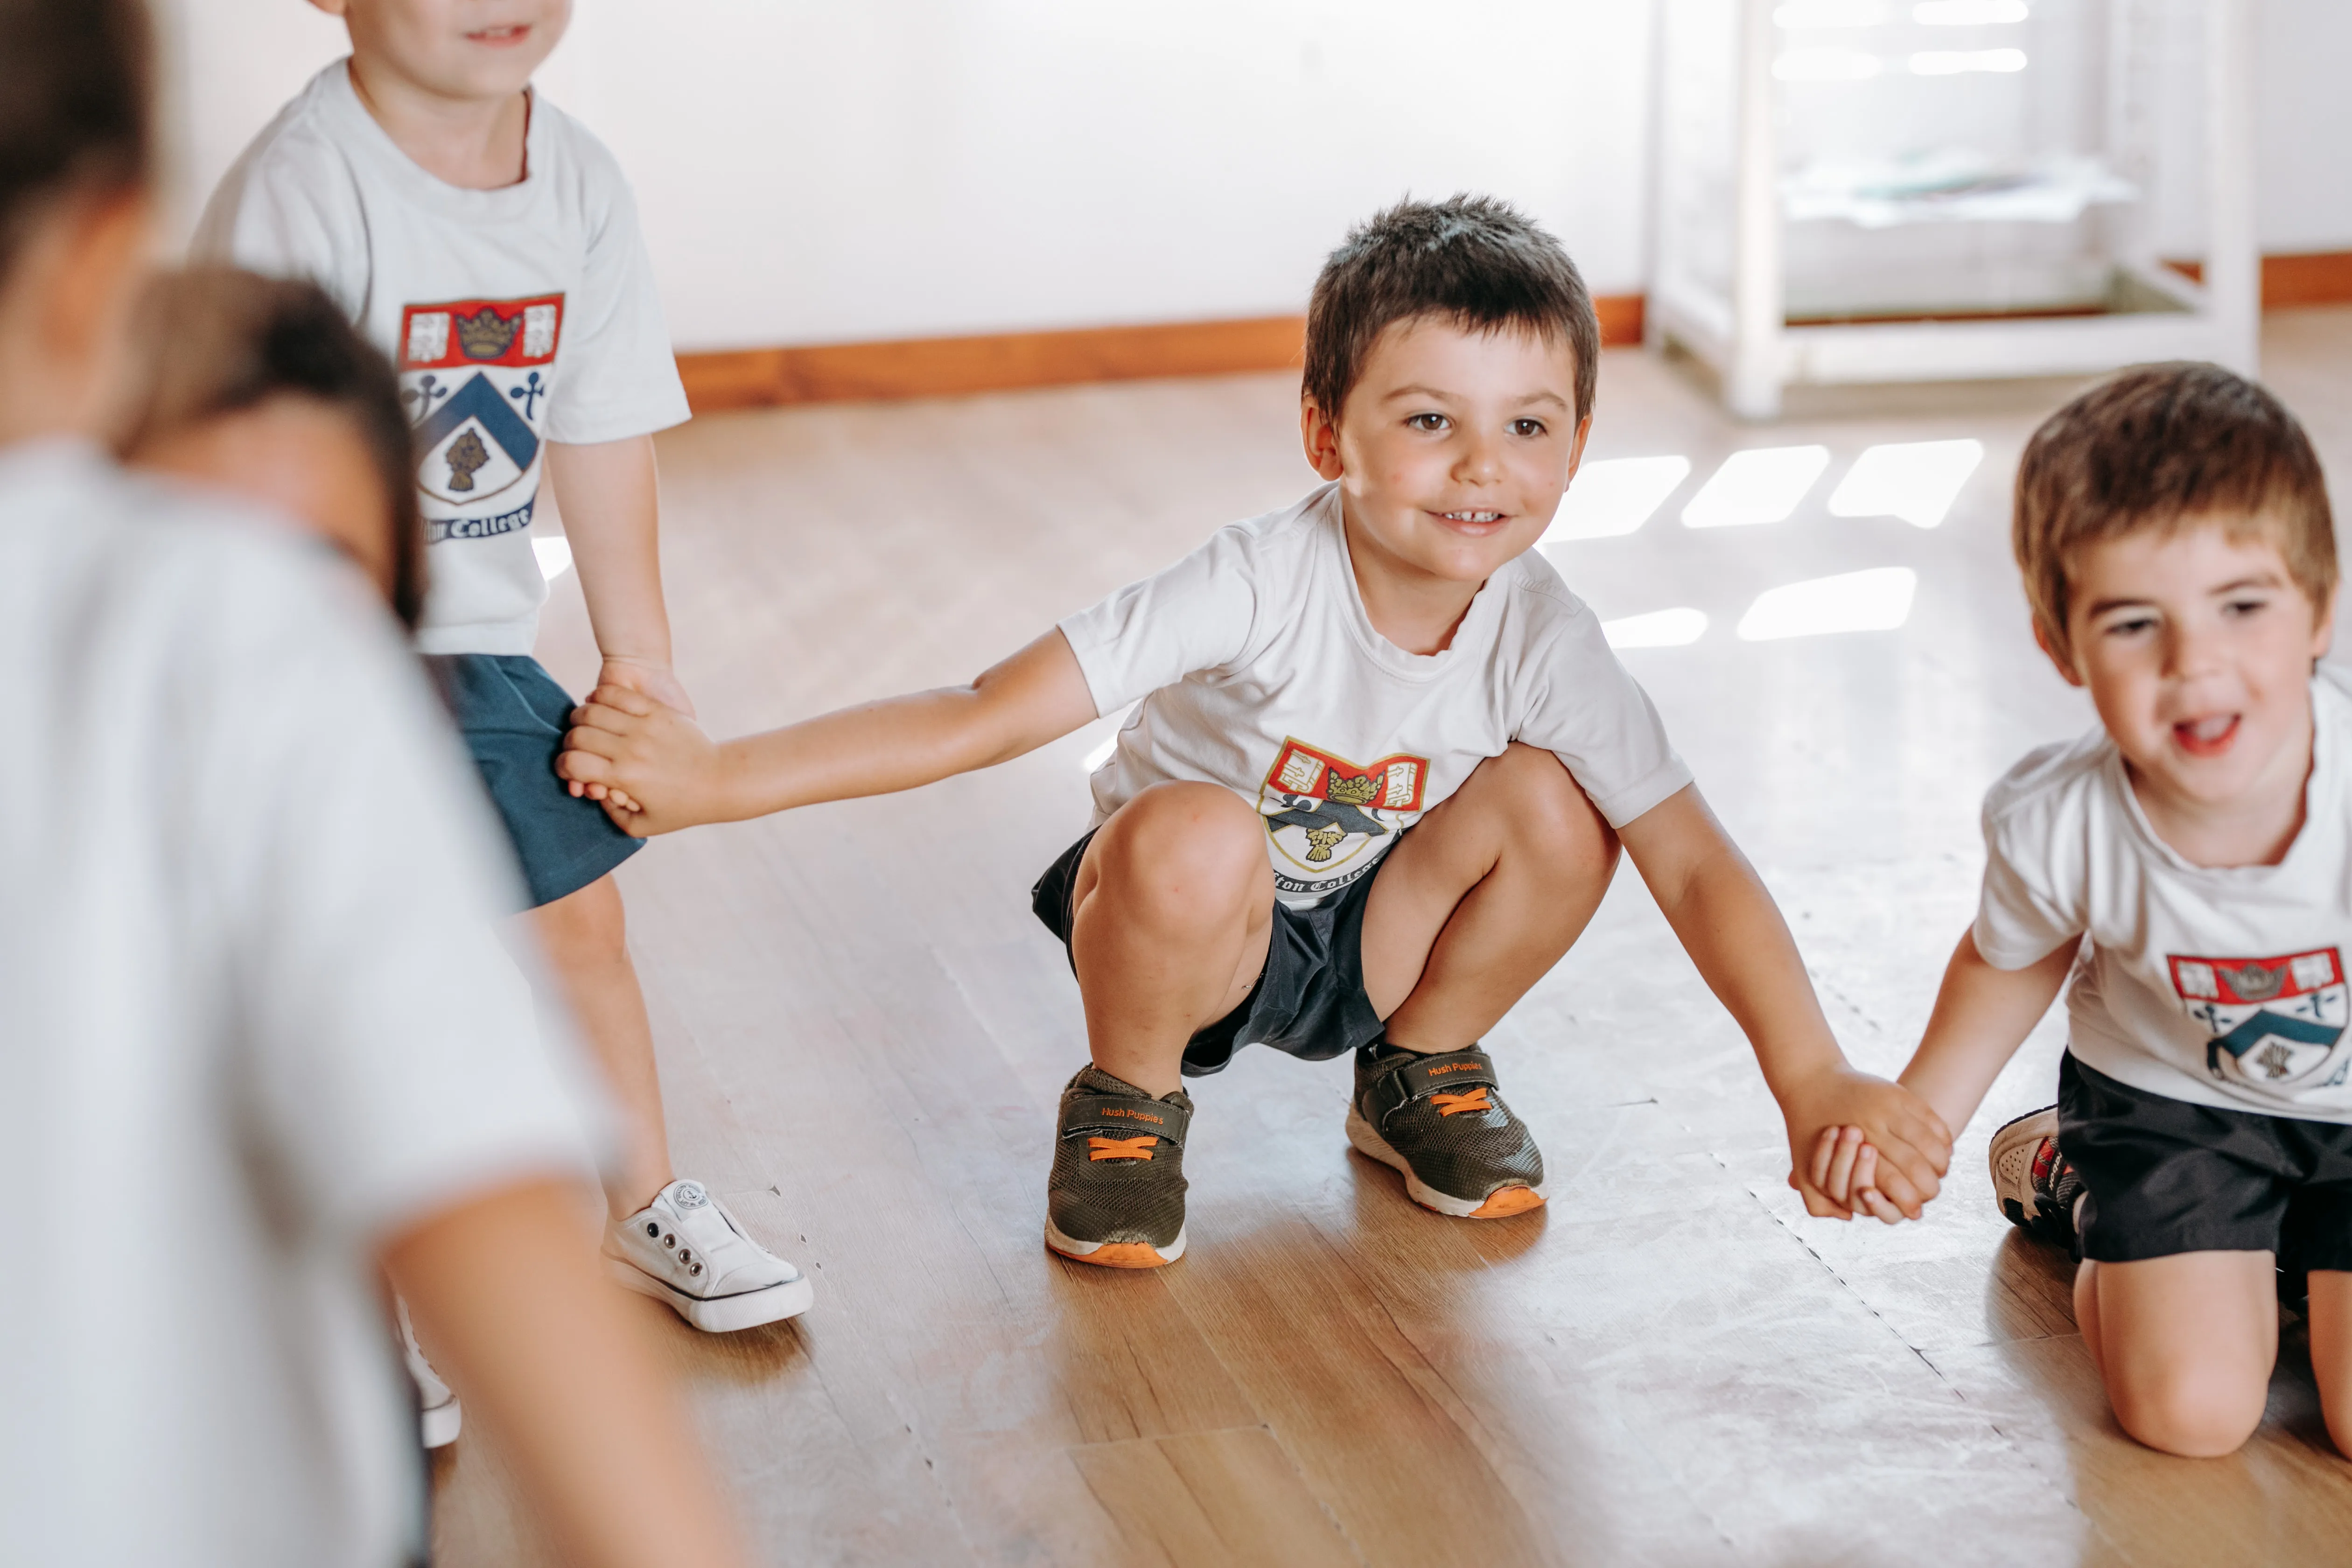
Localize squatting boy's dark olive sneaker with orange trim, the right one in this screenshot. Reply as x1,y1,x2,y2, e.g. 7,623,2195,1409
1348,1039,1543,1220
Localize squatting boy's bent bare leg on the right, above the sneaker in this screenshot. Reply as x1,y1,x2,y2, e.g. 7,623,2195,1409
1364,743,1618,1051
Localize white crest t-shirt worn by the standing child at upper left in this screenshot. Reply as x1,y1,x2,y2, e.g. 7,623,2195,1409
195,61,687,653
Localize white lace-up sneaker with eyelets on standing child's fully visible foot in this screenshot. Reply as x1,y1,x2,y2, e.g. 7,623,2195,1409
604,1180,814,1333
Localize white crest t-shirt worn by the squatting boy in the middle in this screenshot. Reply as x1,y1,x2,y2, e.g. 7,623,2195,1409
1061,484,1691,907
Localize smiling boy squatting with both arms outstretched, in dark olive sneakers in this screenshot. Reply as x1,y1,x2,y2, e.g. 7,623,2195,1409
562,197,1950,1267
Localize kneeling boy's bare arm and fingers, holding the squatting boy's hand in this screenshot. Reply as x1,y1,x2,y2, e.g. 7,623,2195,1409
1806,931,2081,1222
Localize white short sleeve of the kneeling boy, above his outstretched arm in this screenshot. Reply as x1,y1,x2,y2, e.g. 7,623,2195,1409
1971,745,2089,968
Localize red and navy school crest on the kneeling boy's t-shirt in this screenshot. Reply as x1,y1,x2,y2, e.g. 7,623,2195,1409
2164,947,2352,1093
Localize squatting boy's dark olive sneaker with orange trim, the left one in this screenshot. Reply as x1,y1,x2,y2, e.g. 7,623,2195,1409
1044,1065,1192,1269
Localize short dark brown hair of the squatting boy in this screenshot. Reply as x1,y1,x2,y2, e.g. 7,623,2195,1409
1301,195,1602,423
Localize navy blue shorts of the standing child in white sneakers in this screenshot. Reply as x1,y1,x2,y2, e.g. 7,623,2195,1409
426,653,644,910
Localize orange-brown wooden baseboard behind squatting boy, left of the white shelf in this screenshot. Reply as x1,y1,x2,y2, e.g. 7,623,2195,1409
678,294,1642,414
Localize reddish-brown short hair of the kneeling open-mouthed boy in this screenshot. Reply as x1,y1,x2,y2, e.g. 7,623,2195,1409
2009,362,2336,653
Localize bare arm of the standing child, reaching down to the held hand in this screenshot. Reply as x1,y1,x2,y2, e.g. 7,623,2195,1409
548,435,694,712
